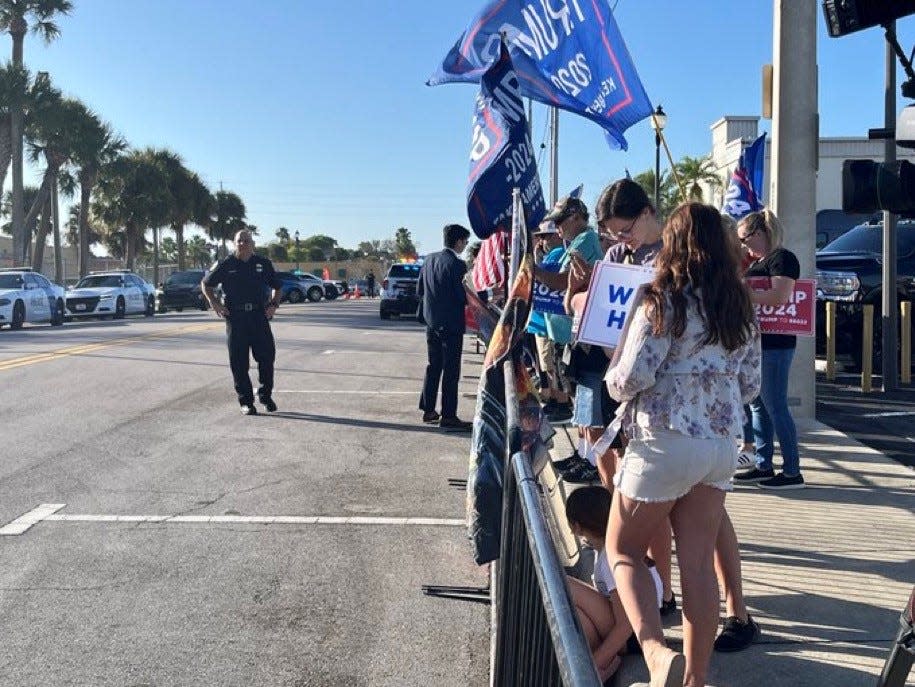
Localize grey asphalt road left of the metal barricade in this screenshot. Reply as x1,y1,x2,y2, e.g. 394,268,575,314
0,300,489,687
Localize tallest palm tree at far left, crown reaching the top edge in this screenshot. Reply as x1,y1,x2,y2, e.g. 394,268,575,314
0,0,73,264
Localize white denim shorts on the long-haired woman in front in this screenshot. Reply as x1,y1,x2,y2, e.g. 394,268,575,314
613,429,739,501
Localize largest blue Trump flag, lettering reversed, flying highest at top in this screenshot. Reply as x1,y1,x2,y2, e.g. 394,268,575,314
427,0,652,150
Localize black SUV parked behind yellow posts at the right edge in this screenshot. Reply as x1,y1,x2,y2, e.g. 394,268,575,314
816,220,915,371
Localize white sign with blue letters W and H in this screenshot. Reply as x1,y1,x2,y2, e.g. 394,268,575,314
578,261,655,348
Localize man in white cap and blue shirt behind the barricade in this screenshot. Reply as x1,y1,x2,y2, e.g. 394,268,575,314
527,222,572,421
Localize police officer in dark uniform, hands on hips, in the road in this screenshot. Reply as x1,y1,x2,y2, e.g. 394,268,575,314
200,230,282,415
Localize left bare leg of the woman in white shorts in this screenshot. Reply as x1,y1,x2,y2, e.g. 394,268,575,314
606,491,680,676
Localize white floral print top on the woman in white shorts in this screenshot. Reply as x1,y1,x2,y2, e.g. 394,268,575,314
606,293,760,439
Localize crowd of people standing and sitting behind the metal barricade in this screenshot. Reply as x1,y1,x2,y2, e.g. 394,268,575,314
528,179,804,687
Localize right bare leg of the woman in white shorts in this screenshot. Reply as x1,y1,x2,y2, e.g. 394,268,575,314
668,484,725,687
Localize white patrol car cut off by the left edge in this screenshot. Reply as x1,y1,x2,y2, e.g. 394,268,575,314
0,267,66,329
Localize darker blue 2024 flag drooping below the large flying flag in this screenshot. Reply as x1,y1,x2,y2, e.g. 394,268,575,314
467,40,546,239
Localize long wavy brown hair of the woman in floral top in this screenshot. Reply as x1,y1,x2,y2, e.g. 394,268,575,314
645,203,756,351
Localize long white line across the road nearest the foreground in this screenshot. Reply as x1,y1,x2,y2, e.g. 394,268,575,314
45,513,465,527
